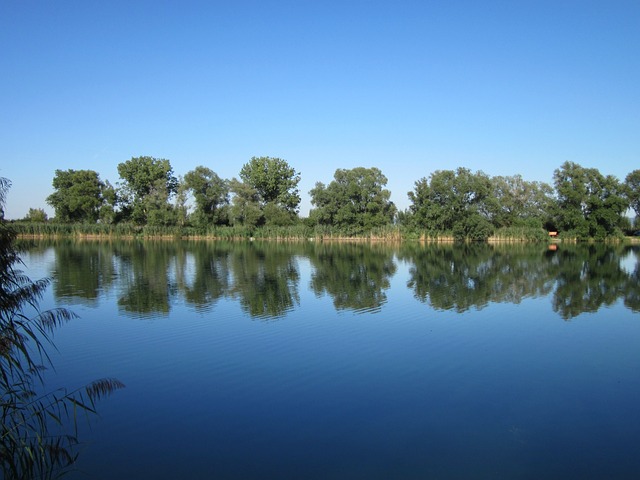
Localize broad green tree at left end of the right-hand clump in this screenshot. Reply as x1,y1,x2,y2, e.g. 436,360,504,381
408,168,492,240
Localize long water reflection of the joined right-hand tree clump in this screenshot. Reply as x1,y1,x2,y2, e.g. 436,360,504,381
400,244,640,319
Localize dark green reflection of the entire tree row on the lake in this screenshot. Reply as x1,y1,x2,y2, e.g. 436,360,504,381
35,241,640,319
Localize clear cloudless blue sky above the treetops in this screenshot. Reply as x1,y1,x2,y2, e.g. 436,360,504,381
0,0,640,218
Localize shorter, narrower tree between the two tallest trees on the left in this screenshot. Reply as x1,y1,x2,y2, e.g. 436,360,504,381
184,166,229,226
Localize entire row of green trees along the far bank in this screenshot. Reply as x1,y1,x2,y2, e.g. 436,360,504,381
33,157,640,239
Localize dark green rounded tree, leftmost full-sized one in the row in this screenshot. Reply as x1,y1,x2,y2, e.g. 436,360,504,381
47,170,106,222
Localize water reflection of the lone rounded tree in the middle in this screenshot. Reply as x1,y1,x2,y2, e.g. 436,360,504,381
309,243,396,311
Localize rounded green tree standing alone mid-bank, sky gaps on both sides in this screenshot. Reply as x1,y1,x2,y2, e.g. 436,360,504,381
309,167,396,233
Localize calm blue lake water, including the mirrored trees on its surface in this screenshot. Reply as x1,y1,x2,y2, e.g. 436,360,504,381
18,242,640,479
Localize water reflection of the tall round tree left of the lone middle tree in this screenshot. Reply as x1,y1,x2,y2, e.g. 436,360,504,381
229,242,300,318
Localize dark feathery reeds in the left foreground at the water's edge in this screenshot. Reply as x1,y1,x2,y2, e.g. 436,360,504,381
0,179,123,479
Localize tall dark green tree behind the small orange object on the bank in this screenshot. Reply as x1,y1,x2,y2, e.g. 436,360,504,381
553,162,629,239
